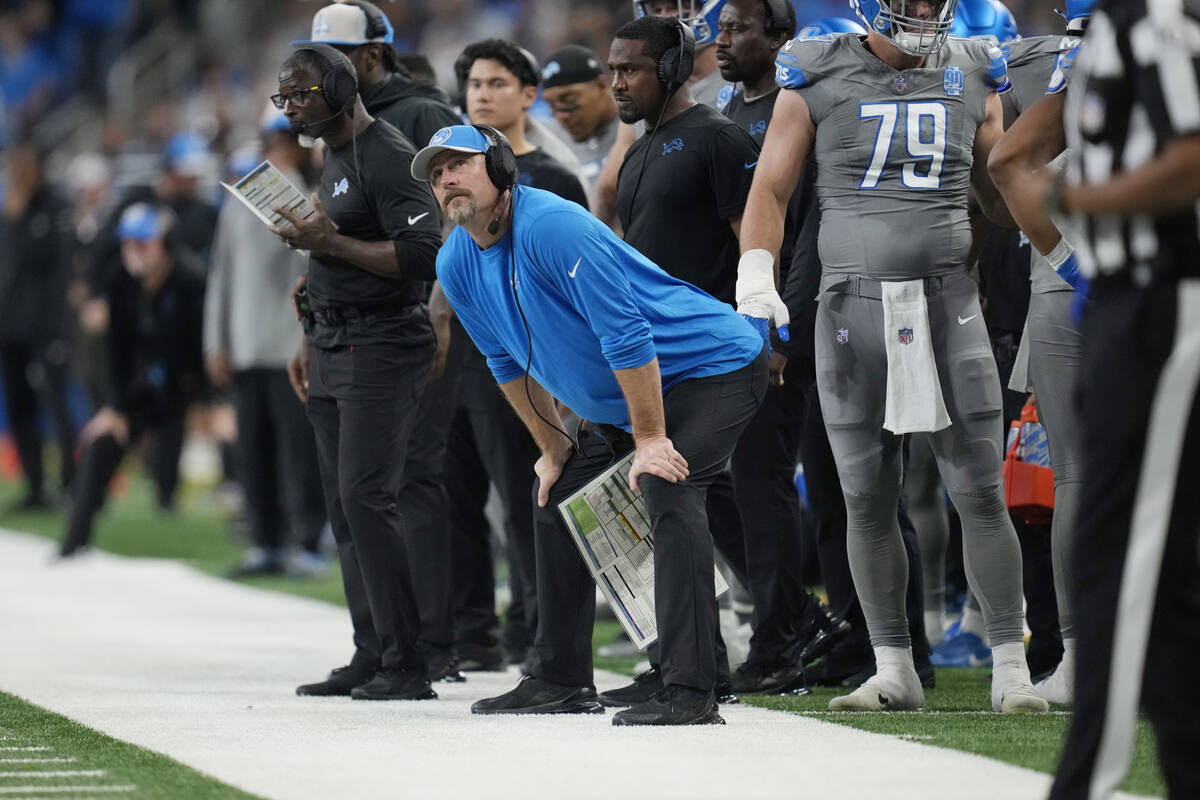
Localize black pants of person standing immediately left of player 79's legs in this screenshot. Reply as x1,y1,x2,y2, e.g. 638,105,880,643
730,359,808,661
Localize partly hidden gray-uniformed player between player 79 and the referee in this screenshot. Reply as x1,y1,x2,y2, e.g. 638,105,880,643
988,0,1094,704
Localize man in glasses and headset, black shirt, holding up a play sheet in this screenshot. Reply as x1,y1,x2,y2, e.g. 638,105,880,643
272,44,442,699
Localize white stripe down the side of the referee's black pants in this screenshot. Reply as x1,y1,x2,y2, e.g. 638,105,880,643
1088,279,1200,800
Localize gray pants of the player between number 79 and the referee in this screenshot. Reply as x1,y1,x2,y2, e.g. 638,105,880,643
1027,291,1084,639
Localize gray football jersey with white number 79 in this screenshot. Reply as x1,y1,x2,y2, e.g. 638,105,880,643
775,34,1008,281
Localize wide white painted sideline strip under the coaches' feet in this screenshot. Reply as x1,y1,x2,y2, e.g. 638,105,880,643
0,530,1156,800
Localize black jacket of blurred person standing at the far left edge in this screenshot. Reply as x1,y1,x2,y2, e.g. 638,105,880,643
0,187,74,343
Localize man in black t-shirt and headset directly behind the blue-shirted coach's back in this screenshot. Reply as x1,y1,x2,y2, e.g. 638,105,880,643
599,17,758,706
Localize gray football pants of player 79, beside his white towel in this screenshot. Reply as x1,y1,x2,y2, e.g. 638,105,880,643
816,272,1025,646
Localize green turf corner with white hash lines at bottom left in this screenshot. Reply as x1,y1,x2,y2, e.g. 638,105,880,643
0,692,256,800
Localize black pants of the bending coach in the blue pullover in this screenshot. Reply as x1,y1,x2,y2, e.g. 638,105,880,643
534,351,767,691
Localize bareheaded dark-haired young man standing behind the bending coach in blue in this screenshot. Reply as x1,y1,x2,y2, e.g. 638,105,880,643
444,40,588,669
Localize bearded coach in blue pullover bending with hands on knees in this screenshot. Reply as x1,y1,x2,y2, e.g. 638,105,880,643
412,125,767,724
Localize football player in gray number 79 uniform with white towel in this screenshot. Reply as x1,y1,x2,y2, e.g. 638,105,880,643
739,0,1048,712
